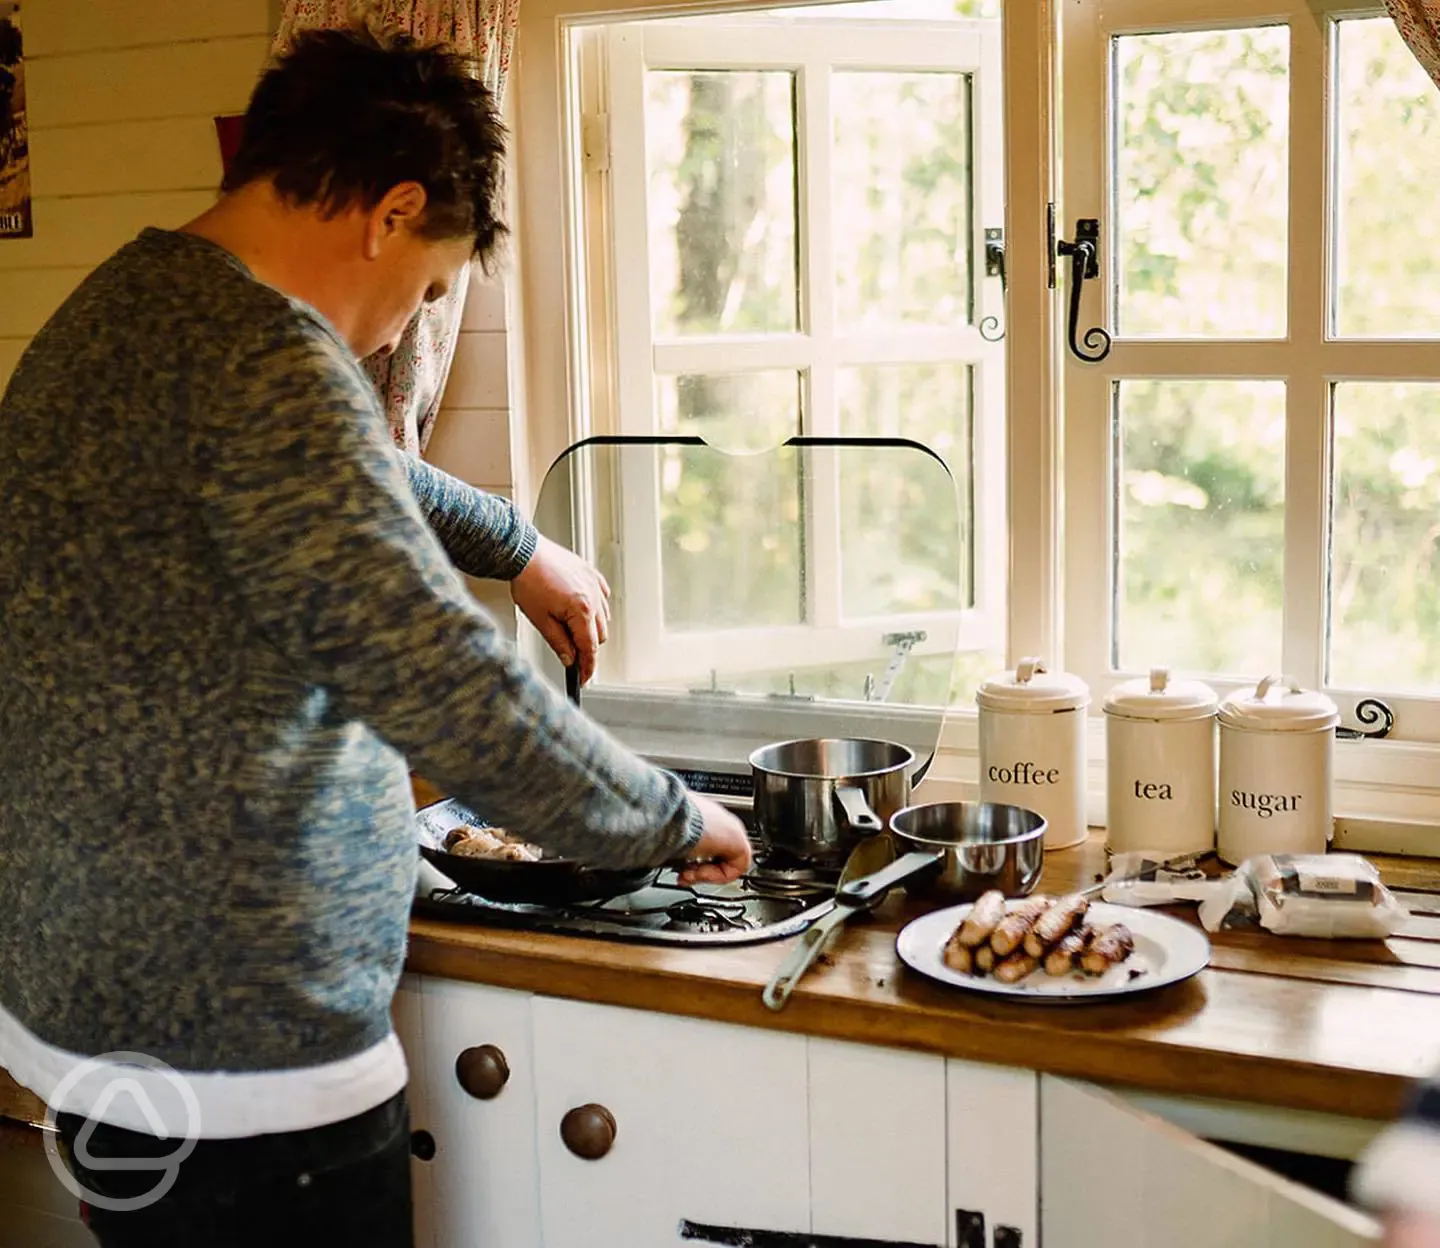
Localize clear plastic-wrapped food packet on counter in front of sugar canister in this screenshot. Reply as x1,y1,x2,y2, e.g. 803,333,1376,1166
1200,854,1410,940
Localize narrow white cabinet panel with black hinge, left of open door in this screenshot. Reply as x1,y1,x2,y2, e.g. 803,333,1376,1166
946,1059,1040,1248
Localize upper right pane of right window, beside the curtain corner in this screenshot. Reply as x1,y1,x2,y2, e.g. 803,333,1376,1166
1335,17,1440,337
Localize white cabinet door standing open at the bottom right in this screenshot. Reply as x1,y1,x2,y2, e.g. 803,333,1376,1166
1040,1075,1380,1248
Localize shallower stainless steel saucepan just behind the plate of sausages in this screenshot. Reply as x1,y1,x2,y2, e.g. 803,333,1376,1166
890,802,1045,903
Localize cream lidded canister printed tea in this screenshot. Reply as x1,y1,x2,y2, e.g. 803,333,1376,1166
1104,668,1218,858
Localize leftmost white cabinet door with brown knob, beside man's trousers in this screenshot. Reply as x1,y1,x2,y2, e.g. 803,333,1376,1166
422,979,543,1248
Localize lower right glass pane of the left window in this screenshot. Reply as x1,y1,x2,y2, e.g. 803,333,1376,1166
835,364,973,618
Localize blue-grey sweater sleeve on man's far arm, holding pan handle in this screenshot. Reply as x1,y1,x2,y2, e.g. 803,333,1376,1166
400,452,540,580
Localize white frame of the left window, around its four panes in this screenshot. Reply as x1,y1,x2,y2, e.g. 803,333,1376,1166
555,14,1005,682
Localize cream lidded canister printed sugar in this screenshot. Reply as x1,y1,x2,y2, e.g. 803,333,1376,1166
1217,677,1339,864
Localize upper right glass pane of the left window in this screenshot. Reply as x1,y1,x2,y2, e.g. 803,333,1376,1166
831,72,971,325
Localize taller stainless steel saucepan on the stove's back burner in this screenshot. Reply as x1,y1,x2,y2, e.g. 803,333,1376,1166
750,737,914,864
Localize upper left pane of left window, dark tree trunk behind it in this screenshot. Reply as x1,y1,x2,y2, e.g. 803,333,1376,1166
645,71,796,337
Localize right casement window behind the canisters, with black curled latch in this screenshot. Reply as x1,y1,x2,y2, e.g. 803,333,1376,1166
1060,0,1440,840
